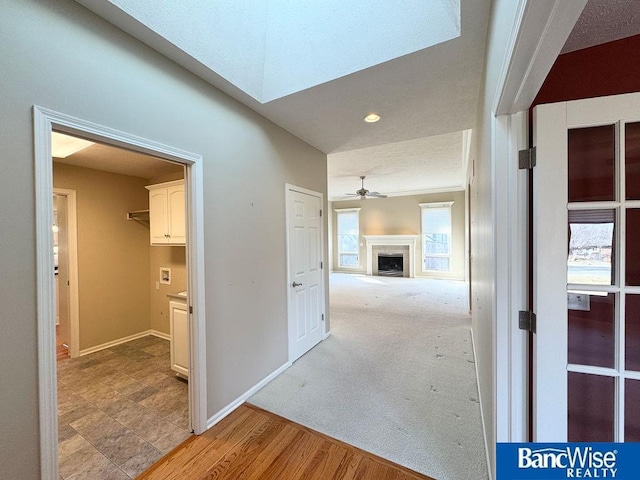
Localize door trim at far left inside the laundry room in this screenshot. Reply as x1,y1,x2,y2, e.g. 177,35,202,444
53,187,80,358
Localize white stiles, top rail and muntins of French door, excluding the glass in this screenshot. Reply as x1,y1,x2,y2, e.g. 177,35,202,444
532,93,640,442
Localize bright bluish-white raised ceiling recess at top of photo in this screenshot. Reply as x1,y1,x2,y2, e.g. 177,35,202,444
99,0,460,103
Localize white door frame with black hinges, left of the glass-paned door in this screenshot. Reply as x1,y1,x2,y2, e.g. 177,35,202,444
490,0,587,446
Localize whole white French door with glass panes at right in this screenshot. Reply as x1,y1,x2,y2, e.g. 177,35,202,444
532,94,640,442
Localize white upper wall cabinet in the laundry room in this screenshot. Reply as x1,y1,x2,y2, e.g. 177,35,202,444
146,180,186,245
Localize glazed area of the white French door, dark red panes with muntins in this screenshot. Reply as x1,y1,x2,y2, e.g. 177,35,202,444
567,121,640,442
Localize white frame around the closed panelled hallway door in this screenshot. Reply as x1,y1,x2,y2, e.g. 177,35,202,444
284,183,329,364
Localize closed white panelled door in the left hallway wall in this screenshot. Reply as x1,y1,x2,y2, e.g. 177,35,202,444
287,186,324,362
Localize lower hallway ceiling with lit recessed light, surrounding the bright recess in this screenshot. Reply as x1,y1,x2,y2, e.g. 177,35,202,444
76,0,491,153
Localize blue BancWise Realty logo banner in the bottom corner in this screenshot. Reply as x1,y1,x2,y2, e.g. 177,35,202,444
496,443,640,480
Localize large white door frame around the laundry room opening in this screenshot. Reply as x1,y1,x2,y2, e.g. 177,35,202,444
33,105,207,479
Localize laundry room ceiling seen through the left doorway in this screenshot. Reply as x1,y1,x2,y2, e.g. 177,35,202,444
53,135,183,179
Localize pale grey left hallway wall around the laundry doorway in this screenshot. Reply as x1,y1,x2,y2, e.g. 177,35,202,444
0,0,328,479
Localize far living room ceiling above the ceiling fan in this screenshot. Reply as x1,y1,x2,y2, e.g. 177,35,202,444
327,130,471,200
